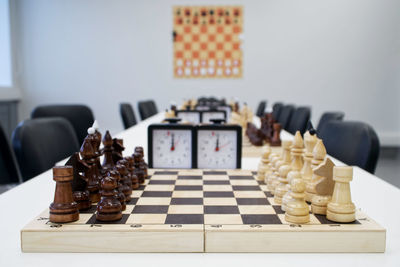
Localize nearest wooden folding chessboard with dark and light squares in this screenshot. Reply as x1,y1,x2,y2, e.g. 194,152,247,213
21,169,386,252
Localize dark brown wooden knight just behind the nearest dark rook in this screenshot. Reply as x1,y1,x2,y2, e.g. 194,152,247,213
65,152,92,210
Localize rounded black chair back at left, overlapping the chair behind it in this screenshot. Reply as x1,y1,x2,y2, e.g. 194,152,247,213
12,117,79,181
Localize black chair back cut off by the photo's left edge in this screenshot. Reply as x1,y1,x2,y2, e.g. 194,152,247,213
0,125,22,184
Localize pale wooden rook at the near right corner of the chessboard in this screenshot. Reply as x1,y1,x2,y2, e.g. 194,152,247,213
326,166,356,223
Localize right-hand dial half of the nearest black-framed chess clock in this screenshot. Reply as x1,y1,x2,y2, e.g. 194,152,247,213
196,124,242,169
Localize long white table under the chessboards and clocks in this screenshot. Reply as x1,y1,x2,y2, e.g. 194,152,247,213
0,114,400,267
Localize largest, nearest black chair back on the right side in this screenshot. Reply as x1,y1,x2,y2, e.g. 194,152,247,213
318,120,379,174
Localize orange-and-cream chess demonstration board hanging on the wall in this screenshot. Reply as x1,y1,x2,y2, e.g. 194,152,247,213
173,6,243,78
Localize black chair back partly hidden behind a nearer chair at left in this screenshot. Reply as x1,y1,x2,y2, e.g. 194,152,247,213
31,105,94,147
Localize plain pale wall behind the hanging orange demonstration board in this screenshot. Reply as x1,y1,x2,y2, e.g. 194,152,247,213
15,0,400,144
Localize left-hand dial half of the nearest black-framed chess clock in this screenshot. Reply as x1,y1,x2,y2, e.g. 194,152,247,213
148,124,196,169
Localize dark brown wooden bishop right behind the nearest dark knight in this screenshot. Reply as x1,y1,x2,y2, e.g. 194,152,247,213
80,138,101,203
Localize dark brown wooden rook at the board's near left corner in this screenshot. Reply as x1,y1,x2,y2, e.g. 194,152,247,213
50,166,79,223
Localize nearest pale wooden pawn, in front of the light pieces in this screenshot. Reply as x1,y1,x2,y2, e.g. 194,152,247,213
285,178,310,224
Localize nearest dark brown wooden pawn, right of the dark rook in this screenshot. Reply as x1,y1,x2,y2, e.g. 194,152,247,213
96,174,122,221
